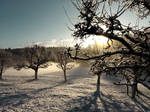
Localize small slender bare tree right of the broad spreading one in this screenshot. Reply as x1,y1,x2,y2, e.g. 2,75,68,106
57,51,73,82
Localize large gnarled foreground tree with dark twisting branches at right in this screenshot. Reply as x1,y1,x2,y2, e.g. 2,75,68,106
68,0,150,97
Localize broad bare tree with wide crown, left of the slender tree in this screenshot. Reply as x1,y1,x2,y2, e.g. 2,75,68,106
15,45,49,80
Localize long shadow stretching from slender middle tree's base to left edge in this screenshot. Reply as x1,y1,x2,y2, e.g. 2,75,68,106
0,80,65,108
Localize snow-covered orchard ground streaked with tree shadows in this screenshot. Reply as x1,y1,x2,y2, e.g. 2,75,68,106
0,64,150,112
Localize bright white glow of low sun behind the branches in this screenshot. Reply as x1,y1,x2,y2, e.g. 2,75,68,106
83,36,108,48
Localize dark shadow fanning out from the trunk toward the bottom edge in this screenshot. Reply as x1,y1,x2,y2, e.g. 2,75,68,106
67,86,149,112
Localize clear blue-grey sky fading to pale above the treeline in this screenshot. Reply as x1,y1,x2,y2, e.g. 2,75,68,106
0,0,147,48
